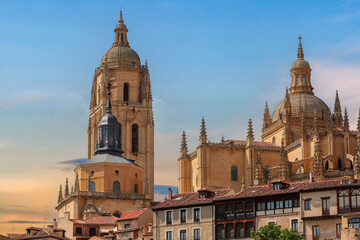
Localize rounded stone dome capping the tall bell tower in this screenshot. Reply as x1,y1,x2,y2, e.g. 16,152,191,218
101,45,140,66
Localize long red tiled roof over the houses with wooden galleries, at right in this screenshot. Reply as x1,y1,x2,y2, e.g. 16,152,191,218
216,180,360,200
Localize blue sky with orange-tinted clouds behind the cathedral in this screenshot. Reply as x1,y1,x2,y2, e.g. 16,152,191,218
0,0,360,234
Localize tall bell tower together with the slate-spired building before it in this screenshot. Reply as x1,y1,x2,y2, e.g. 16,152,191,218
56,12,154,227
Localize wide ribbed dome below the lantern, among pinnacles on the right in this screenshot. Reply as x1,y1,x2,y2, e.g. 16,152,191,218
272,92,329,122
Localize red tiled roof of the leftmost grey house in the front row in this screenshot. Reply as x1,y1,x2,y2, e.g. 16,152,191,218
152,188,232,210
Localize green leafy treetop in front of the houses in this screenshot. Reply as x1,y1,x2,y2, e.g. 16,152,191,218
251,224,303,240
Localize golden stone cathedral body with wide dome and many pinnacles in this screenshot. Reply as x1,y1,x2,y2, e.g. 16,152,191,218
178,37,360,193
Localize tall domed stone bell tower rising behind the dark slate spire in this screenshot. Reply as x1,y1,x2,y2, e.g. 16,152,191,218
88,12,154,199
